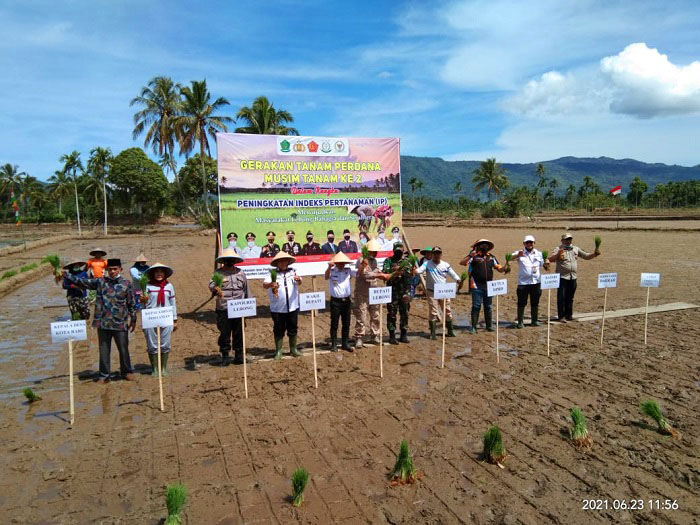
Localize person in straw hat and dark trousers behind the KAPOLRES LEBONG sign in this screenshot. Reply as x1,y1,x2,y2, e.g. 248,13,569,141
209,247,249,366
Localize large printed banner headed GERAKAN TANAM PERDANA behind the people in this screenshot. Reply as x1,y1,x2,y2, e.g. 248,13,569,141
216,133,401,279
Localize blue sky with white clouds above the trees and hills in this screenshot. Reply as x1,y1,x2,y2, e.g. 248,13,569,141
0,0,700,179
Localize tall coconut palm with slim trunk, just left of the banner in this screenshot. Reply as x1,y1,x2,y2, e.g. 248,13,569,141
174,80,235,219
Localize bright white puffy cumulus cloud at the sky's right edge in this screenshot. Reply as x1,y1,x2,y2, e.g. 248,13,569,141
504,43,700,118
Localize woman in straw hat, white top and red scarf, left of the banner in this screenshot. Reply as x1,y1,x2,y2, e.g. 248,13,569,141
143,263,177,376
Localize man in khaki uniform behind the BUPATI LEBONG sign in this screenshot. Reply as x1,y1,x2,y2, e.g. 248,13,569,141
353,239,389,350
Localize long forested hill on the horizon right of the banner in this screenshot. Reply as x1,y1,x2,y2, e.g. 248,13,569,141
401,155,700,197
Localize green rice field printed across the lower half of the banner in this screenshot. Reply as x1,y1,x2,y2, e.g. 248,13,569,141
220,192,401,238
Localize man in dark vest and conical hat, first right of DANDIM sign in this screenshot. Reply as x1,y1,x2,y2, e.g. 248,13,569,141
459,239,510,334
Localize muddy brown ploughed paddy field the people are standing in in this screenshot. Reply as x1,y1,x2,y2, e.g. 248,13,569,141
0,228,700,524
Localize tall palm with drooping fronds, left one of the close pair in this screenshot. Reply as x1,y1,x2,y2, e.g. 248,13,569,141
129,77,182,178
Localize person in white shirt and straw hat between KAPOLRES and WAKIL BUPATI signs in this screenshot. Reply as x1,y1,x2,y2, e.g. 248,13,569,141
263,252,301,359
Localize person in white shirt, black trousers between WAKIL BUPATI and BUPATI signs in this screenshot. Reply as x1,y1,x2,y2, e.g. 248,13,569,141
325,252,357,352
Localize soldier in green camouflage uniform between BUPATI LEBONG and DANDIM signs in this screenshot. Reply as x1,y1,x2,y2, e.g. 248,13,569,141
382,241,415,345
